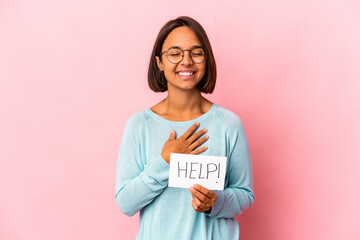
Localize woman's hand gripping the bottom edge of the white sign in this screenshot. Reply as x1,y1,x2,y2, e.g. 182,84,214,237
189,184,217,212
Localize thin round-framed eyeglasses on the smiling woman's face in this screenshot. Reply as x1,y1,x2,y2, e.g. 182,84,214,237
160,47,206,64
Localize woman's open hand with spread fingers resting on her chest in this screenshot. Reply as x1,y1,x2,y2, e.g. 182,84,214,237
161,123,209,163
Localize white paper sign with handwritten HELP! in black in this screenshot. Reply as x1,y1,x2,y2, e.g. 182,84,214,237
168,153,227,190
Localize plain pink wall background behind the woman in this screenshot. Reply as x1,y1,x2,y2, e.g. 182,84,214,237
0,0,360,240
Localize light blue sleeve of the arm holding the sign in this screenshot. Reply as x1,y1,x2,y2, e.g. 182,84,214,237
206,116,254,218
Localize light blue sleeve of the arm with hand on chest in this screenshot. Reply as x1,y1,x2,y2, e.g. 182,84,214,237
115,116,169,216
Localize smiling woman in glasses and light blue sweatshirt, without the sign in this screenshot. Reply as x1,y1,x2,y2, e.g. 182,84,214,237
115,17,254,240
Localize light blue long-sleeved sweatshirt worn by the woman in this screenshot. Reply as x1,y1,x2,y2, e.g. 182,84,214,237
115,104,254,240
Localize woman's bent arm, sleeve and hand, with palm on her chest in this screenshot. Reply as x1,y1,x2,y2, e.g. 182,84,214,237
115,118,208,216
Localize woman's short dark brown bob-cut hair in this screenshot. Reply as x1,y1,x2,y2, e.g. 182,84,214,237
148,16,216,93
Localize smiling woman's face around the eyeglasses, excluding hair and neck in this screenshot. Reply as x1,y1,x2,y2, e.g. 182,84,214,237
156,27,206,91
